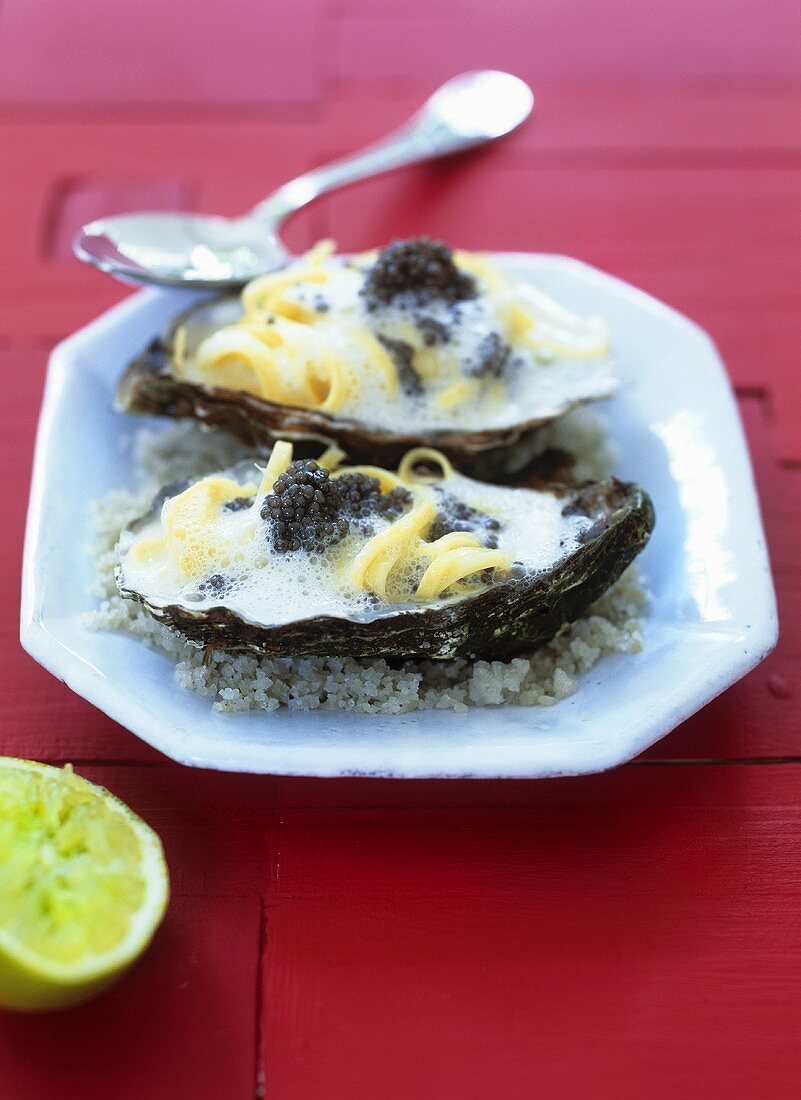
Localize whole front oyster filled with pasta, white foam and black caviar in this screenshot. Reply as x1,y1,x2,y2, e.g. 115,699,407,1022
117,441,654,659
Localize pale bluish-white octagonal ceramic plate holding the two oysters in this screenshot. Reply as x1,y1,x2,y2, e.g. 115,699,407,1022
21,254,777,778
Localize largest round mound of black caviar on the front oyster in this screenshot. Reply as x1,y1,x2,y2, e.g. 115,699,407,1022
262,459,349,553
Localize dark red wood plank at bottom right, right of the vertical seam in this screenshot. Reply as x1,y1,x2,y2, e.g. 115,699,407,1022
264,767,801,1100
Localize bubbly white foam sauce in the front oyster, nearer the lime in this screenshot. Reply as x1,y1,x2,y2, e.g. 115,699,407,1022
119,475,590,626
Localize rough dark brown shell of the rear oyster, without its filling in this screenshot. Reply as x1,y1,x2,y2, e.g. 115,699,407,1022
116,296,616,481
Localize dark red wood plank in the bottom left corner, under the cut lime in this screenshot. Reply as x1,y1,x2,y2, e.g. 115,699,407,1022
0,894,260,1100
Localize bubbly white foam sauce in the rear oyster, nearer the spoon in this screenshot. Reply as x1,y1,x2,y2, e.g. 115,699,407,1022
185,260,616,431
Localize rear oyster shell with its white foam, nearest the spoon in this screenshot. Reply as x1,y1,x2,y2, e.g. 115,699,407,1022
117,242,616,480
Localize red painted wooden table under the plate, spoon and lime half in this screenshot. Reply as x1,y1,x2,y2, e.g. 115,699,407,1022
0,0,801,1100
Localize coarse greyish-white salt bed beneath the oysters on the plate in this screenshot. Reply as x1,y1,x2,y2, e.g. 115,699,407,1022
85,409,648,714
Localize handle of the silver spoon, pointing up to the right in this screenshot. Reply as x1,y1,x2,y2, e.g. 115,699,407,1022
246,73,534,227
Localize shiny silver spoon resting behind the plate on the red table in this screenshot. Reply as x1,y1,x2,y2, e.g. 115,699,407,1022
73,70,534,287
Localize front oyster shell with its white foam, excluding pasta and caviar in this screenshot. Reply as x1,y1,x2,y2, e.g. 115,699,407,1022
118,446,654,660
